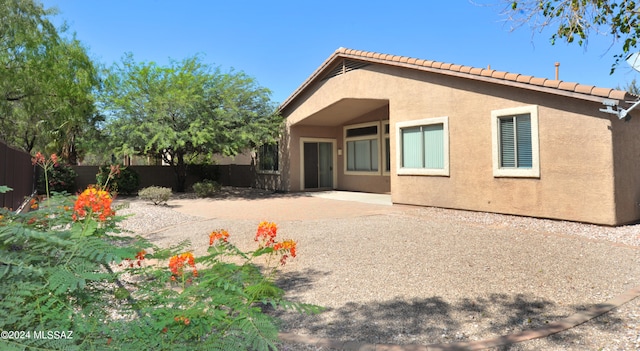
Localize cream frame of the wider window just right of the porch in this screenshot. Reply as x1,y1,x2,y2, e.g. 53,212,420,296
395,116,450,177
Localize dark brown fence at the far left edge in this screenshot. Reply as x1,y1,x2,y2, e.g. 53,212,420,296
0,141,35,210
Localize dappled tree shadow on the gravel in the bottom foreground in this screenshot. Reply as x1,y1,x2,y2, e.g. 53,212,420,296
276,286,622,350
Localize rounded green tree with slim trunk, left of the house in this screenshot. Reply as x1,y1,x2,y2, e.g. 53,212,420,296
101,54,282,191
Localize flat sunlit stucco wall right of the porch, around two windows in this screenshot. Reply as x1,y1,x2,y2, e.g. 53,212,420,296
390,65,616,224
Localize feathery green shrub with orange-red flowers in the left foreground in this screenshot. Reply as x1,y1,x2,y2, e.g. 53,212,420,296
0,155,320,351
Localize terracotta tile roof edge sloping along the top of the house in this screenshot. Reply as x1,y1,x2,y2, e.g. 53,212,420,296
280,48,633,110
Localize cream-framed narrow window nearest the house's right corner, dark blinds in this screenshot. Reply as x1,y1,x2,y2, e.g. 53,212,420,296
491,106,540,178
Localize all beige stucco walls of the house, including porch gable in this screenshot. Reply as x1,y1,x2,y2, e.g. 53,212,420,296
284,65,640,225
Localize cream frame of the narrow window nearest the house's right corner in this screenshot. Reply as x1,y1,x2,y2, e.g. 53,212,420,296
491,105,540,178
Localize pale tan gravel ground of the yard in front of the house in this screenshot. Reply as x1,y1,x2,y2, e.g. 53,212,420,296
118,192,640,351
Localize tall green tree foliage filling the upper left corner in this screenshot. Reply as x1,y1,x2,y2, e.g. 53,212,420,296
0,0,100,163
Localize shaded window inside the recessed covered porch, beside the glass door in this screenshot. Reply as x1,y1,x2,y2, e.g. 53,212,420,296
344,122,380,174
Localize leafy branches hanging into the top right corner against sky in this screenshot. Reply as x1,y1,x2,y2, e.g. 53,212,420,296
505,0,640,73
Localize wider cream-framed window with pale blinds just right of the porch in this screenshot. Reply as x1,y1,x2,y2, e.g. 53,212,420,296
396,117,449,176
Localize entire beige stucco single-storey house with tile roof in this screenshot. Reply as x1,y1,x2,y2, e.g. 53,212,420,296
257,48,640,225
